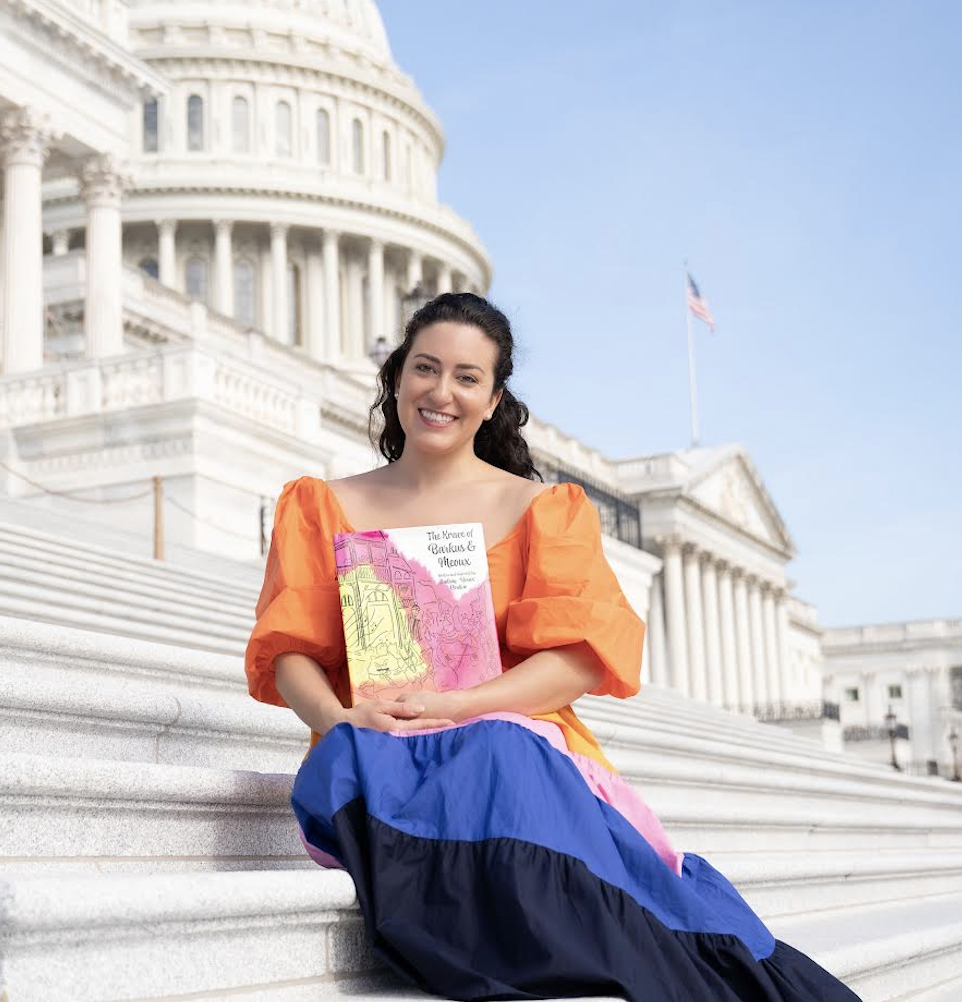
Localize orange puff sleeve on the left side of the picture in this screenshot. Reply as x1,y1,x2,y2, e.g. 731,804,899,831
245,477,347,706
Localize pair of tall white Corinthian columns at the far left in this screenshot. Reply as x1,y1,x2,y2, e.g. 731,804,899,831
0,107,128,374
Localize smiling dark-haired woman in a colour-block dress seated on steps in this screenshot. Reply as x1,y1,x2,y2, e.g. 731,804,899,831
247,293,858,1002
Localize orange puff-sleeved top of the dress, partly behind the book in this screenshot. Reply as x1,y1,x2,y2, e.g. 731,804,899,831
245,477,645,772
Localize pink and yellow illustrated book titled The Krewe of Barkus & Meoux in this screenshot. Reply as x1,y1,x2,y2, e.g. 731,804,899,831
334,522,502,705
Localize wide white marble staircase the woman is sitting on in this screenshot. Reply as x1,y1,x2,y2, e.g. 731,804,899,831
0,509,962,1002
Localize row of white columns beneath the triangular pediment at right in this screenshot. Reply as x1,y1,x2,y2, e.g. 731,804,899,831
648,537,792,708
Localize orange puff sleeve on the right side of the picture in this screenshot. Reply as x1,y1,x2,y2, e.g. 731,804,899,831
505,483,645,699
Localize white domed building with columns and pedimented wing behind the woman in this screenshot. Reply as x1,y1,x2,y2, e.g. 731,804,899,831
0,0,944,773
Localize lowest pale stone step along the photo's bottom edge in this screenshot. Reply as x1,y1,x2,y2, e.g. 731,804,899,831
0,871,949,1002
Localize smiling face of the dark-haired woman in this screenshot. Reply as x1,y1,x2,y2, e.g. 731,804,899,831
396,322,501,451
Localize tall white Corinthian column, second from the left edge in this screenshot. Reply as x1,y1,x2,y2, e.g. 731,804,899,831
80,154,129,359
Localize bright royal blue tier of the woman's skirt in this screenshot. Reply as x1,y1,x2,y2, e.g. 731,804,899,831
292,720,775,958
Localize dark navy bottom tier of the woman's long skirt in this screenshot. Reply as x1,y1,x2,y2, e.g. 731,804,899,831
333,798,859,1002
